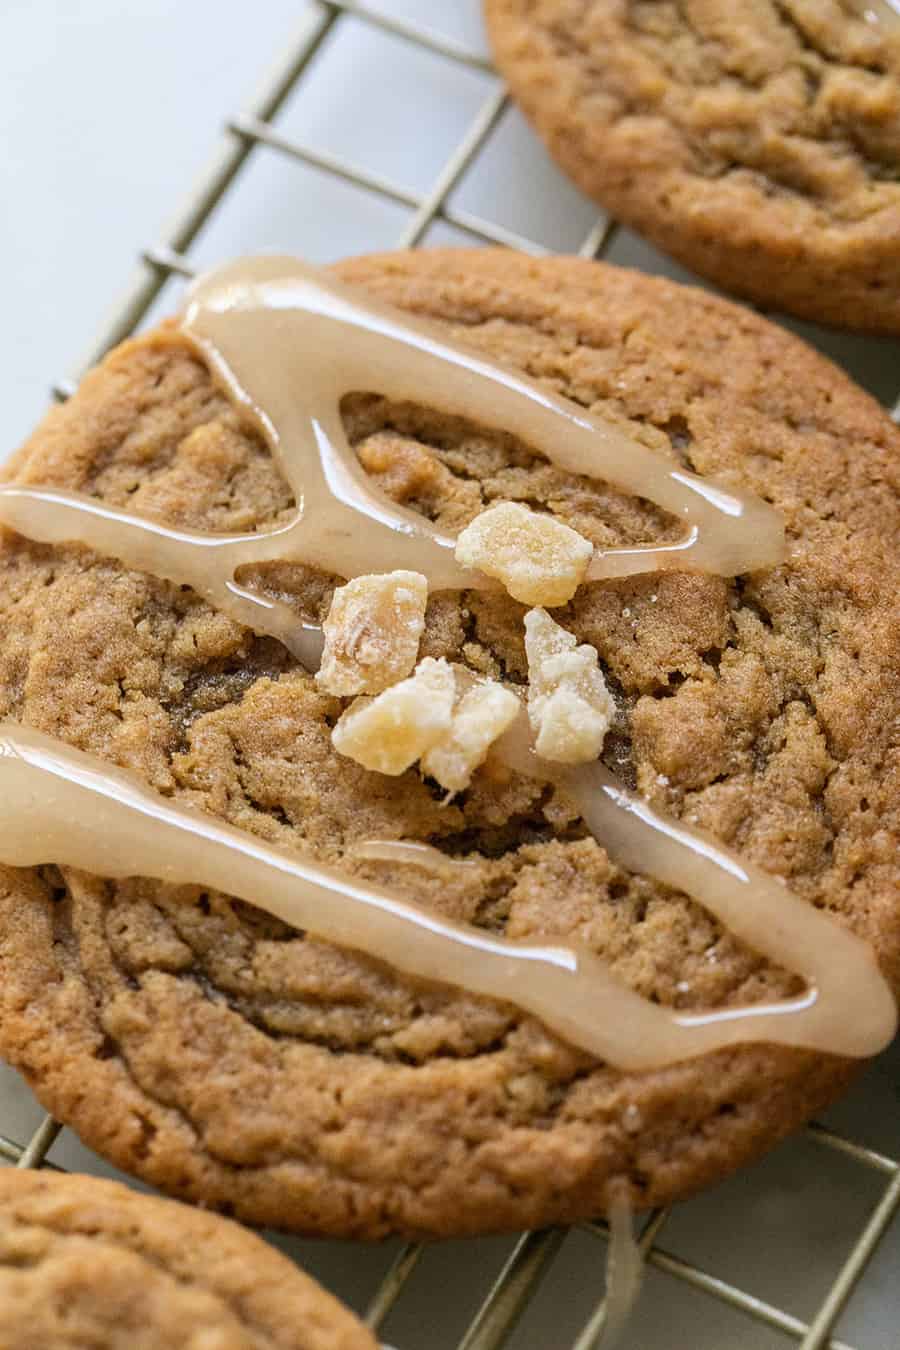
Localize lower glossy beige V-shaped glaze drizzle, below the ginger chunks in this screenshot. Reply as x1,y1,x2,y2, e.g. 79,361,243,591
0,724,896,1071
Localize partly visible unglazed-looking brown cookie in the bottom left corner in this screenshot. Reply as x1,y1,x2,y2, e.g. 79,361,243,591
0,1168,375,1350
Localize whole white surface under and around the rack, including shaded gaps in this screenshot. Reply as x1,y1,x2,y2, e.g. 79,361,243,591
0,0,900,1350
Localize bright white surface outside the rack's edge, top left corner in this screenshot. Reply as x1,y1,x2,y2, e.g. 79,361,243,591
0,0,297,451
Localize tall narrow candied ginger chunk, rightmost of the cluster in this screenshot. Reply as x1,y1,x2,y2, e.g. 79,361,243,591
525,609,614,764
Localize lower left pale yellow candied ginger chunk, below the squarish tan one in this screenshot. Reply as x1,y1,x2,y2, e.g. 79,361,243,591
332,656,456,775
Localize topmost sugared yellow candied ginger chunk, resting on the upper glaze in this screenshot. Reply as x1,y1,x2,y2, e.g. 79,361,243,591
456,502,594,605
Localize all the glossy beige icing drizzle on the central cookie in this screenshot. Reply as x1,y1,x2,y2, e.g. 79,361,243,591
0,258,896,1069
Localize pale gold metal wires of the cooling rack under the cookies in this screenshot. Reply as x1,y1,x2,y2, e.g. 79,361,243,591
7,0,900,1350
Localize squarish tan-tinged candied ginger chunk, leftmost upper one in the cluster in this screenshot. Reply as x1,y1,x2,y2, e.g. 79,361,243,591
316,571,428,697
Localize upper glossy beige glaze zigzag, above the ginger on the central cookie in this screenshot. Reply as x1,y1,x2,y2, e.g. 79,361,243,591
0,258,784,670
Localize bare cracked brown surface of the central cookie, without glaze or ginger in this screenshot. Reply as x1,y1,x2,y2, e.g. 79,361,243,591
0,251,900,1237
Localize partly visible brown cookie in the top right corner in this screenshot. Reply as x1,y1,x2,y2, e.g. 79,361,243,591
486,0,900,333
